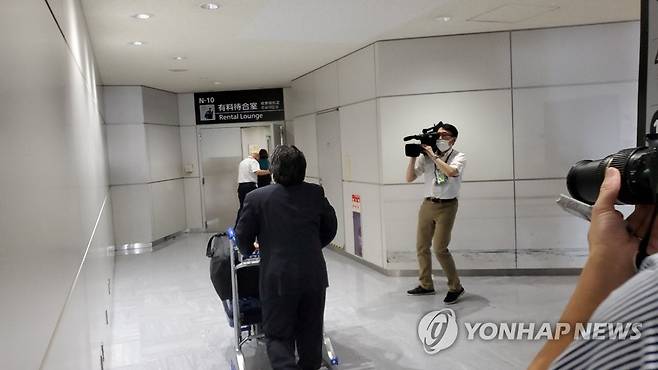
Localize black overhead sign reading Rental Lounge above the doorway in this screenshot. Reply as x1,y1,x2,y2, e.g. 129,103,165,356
194,89,285,125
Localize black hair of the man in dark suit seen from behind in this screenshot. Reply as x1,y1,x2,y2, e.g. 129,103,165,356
270,145,306,186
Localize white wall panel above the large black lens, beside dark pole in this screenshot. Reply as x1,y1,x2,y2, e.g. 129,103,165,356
514,82,637,179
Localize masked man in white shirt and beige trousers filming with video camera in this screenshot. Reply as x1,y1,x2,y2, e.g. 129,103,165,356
406,124,466,304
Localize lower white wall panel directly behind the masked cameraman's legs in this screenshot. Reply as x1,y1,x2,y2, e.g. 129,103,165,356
382,181,515,269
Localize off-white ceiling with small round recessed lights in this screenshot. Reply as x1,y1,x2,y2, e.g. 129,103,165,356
82,0,640,92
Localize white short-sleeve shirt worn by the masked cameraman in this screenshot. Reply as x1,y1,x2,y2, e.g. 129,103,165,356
414,149,466,199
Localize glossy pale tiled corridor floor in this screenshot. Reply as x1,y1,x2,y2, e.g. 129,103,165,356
106,234,576,370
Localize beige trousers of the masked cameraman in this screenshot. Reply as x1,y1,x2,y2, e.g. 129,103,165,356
416,199,462,292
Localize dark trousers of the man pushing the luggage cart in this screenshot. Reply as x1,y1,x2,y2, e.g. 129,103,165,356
261,289,326,370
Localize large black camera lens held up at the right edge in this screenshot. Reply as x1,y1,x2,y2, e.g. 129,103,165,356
567,147,658,204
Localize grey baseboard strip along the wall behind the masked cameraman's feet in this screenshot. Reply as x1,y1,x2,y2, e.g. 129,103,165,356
327,245,582,277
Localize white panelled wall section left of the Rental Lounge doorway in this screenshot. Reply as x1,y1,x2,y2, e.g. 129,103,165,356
103,86,186,245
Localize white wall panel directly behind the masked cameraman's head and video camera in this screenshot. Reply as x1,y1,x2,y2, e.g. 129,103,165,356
379,90,513,184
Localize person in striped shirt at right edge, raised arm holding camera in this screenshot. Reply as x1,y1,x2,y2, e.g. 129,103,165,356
529,168,658,370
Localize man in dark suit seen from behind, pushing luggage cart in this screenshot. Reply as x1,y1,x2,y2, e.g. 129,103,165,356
234,145,337,370
